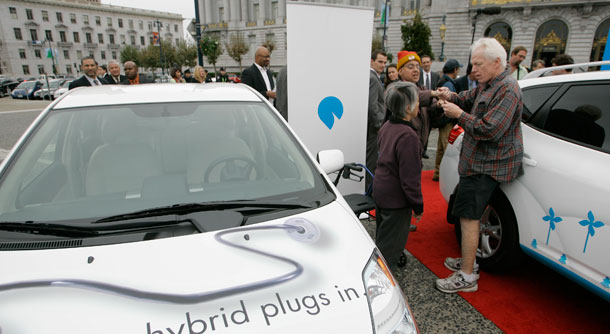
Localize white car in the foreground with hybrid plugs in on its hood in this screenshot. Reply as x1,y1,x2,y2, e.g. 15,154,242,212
0,84,418,334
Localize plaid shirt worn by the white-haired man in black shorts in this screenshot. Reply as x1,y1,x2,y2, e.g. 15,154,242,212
451,71,523,182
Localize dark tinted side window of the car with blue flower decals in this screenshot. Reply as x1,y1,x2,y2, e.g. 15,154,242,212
544,84,610,151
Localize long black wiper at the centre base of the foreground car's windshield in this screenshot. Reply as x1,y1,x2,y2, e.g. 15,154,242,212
92,200,312,224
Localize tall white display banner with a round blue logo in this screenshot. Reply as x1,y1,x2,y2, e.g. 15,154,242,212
286,2,374,194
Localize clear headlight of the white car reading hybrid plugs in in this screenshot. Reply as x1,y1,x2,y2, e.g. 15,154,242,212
362,250,419,334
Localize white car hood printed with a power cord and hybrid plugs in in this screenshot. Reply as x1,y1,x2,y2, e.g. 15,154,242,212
0,202,374,334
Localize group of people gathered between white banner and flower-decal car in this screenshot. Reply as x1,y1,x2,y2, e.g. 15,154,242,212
366,38,574,293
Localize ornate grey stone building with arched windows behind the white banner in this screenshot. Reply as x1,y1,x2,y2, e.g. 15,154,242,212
199,0,610,72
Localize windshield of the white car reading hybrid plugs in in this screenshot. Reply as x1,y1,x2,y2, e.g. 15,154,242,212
0,102,334,222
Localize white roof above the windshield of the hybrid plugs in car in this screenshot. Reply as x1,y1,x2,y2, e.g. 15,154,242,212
53,83,262,109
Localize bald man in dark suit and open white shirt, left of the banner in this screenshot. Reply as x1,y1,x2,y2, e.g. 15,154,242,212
241,46,276,103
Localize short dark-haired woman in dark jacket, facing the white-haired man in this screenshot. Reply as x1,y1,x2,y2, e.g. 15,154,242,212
373,82,424,270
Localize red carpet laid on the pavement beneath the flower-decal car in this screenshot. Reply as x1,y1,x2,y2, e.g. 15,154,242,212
406,171,610,334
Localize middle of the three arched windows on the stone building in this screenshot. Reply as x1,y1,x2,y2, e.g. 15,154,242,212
533,20,568,67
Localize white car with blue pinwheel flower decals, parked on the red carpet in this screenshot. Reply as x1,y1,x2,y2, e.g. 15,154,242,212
439,62,610,301
